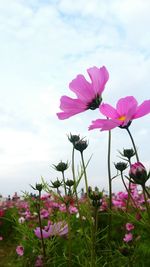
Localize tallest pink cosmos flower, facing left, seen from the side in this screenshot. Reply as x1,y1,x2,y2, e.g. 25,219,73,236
57,66,109,120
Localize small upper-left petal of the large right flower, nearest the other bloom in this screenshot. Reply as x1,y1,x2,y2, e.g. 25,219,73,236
99,103,119,119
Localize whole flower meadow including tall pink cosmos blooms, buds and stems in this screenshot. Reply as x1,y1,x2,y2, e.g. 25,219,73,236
0,66,150,267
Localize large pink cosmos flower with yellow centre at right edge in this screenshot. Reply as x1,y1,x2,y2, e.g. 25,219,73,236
89,96,150,131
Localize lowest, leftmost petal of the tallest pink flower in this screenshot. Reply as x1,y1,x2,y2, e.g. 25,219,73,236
57,96,87,120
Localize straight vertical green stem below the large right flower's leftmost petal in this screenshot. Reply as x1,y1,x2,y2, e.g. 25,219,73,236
107,131,112,241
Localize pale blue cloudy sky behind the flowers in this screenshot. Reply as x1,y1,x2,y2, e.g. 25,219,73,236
0,0,150,196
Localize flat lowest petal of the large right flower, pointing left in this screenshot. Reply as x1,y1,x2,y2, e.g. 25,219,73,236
89,119,120,131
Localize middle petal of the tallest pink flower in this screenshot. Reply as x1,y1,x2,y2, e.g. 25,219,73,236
69,74,95,103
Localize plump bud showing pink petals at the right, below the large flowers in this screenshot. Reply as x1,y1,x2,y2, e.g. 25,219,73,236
129,162,150,186
